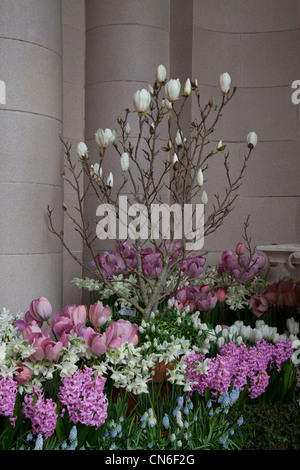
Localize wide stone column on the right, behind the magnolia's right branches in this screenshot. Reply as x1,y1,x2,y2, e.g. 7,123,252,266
193,0,300,266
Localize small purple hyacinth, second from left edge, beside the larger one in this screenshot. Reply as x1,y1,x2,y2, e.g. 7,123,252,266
22,387,57,439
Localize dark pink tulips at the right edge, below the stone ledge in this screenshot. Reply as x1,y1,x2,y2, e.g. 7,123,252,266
250,279,300,317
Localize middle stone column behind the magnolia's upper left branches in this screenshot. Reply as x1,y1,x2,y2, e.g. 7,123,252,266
84,0,170,280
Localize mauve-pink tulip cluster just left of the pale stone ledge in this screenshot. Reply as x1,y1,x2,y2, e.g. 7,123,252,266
219,243,266,284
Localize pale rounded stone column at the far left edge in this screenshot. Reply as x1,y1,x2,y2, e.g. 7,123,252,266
0,0,63,311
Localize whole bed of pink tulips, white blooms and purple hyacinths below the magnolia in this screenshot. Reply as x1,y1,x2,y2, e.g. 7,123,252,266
0,244,300,450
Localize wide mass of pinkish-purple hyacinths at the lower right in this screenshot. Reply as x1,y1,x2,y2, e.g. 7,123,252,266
186,340,293,399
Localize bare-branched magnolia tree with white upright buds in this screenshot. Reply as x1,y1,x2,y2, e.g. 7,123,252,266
48,65,257,319
